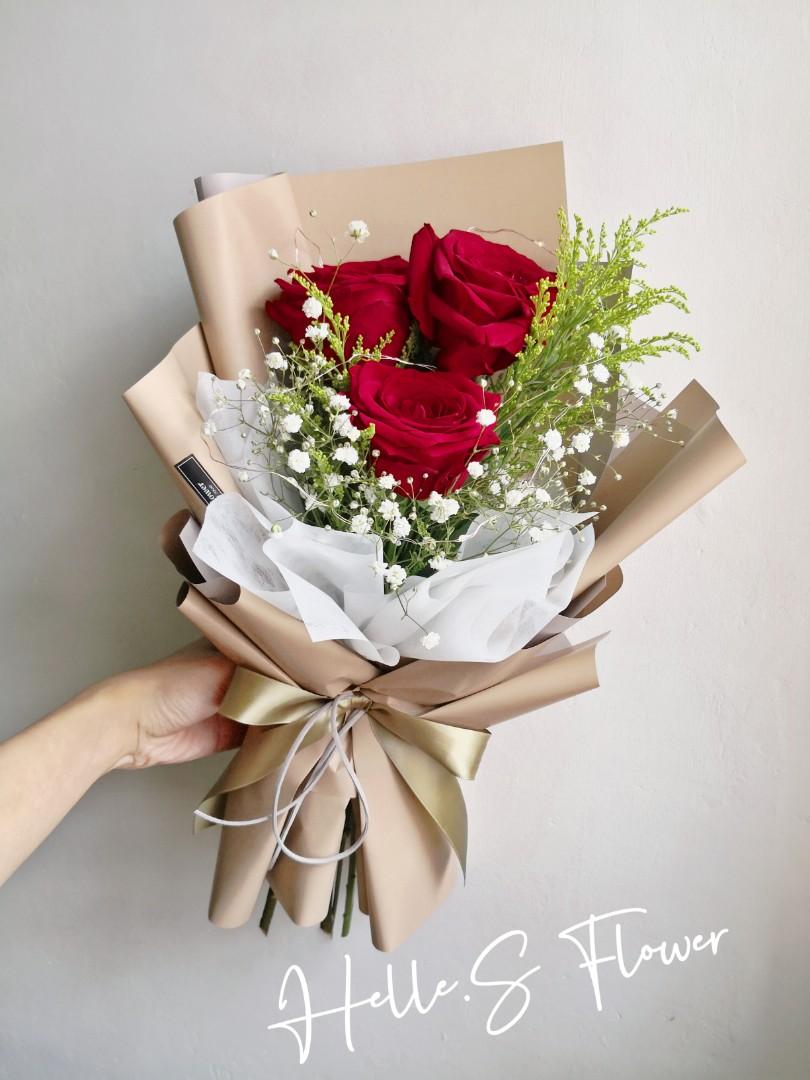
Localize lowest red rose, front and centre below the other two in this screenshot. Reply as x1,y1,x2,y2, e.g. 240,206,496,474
349,361,500,499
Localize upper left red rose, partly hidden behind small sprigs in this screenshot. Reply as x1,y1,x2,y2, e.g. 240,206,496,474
265,255,410,356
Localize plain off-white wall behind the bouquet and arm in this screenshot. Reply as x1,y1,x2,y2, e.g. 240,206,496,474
0,0,810,1080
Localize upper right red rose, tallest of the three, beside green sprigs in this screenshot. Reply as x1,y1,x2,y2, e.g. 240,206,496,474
408,225,556,375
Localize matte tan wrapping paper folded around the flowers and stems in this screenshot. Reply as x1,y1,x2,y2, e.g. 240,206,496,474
125,144,744,950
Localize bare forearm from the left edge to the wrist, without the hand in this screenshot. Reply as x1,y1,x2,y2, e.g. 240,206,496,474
0,680,133,885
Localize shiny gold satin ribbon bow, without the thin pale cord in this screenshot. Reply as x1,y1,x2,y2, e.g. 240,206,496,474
195,667,489,872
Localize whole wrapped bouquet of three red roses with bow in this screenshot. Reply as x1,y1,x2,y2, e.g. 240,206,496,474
126,144,743,950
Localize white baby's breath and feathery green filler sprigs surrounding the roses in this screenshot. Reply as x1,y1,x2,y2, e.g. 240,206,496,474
204,210,698,596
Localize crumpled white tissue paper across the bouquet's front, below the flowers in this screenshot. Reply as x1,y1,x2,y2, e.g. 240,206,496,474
186,494,594,665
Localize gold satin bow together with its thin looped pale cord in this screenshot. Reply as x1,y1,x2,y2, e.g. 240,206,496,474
195,667,489,872
